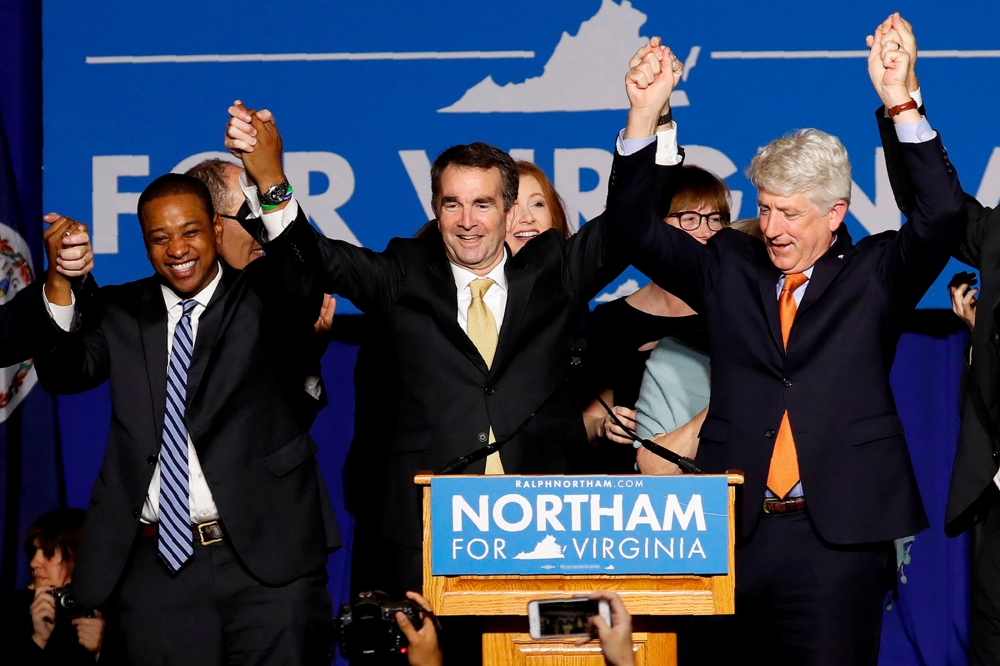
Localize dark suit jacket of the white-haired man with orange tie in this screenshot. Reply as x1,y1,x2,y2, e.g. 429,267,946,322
608,139,962,544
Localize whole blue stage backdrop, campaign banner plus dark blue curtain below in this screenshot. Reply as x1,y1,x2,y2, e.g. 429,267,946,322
0,0,988,664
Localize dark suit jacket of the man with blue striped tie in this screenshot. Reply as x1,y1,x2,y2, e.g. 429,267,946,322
36,210,336,606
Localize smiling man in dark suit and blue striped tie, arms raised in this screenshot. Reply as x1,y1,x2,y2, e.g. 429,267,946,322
37,141,336,664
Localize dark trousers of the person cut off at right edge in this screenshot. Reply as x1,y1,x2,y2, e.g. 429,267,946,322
969,484,1000,666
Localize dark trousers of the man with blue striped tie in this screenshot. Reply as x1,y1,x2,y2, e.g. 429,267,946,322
116,537,333,666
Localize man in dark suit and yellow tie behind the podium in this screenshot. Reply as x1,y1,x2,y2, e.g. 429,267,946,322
227,107,625,594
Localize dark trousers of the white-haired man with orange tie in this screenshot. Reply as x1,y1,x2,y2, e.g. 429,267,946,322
724,511,896,666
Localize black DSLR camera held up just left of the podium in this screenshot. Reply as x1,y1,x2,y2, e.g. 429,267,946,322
337,590,423,664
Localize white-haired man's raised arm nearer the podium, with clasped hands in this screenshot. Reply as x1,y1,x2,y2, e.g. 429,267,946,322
607,38,717,311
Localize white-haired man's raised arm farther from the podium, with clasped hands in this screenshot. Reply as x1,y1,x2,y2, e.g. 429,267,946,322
867,17,966,308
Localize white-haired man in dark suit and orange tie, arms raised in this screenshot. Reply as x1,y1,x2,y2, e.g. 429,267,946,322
608,31,963,665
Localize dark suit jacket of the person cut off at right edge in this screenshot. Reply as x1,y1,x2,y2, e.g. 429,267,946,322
876,107,1000,536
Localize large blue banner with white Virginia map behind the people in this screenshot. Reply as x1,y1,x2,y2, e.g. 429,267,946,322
43,0,1000,313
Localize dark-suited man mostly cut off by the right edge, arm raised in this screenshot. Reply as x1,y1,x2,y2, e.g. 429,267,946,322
876,16,1000,666
